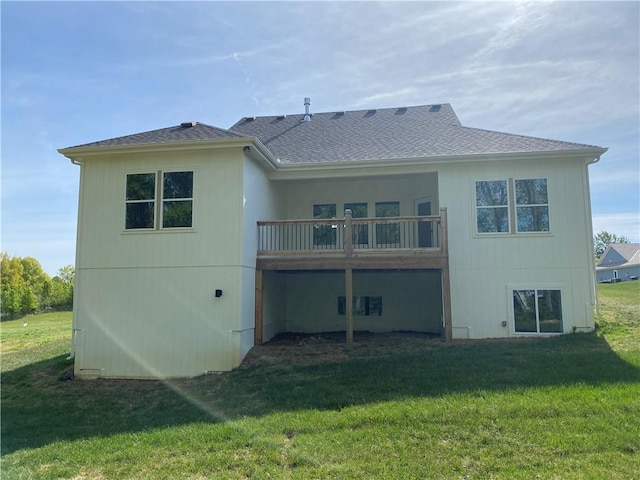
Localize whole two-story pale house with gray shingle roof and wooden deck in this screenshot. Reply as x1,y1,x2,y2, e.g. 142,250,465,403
59,99,606,378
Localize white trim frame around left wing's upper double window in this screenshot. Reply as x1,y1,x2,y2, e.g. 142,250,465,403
122,167,197,235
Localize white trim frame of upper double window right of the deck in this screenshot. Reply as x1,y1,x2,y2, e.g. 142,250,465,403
471,175,553,238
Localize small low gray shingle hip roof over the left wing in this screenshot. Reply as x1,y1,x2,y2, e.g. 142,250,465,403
70,122,245,148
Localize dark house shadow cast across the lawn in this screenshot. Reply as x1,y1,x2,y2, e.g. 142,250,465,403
2,334,640,454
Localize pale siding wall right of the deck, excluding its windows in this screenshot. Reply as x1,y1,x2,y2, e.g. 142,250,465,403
438,159,594,338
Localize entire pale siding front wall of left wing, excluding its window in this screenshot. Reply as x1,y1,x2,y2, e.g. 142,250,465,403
74,149,248,377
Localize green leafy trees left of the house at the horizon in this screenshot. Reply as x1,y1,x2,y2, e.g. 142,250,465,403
0,252,75,318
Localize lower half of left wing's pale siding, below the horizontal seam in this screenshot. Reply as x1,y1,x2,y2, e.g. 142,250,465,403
75,267,241,378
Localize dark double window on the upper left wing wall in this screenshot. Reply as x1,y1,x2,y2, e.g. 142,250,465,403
125,172,193,230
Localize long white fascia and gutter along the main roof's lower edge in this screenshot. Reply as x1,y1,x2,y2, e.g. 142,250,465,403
269,148,607,180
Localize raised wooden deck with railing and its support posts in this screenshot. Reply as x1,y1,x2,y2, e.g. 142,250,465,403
255,208,451,345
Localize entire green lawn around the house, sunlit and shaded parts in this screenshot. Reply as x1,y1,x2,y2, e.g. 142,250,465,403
1,282,640,480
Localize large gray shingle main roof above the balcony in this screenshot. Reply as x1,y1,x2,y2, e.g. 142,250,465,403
230,104,597,163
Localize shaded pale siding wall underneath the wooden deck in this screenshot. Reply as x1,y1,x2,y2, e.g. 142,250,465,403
281,270,442,333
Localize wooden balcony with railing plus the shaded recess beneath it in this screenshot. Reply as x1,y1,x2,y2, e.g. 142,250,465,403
255,209,451,344
